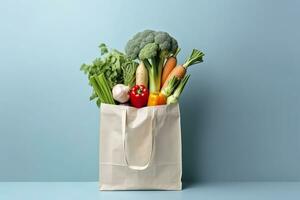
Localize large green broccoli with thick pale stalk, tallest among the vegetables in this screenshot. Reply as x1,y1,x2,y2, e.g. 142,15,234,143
125,30,178,92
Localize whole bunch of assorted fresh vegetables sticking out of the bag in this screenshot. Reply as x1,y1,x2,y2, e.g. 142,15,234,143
81,30,204,108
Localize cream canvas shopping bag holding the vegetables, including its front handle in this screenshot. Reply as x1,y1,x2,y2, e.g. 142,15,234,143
99,104,182,190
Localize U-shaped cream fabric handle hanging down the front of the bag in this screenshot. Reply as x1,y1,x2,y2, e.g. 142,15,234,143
122,108,155,170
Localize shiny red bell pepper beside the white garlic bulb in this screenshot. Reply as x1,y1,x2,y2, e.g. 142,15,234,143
130,85,149,108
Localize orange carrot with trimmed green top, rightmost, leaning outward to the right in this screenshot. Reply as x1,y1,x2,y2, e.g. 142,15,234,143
161,49,204,89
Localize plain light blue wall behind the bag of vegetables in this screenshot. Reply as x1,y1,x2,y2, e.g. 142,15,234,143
0,0,300,181
